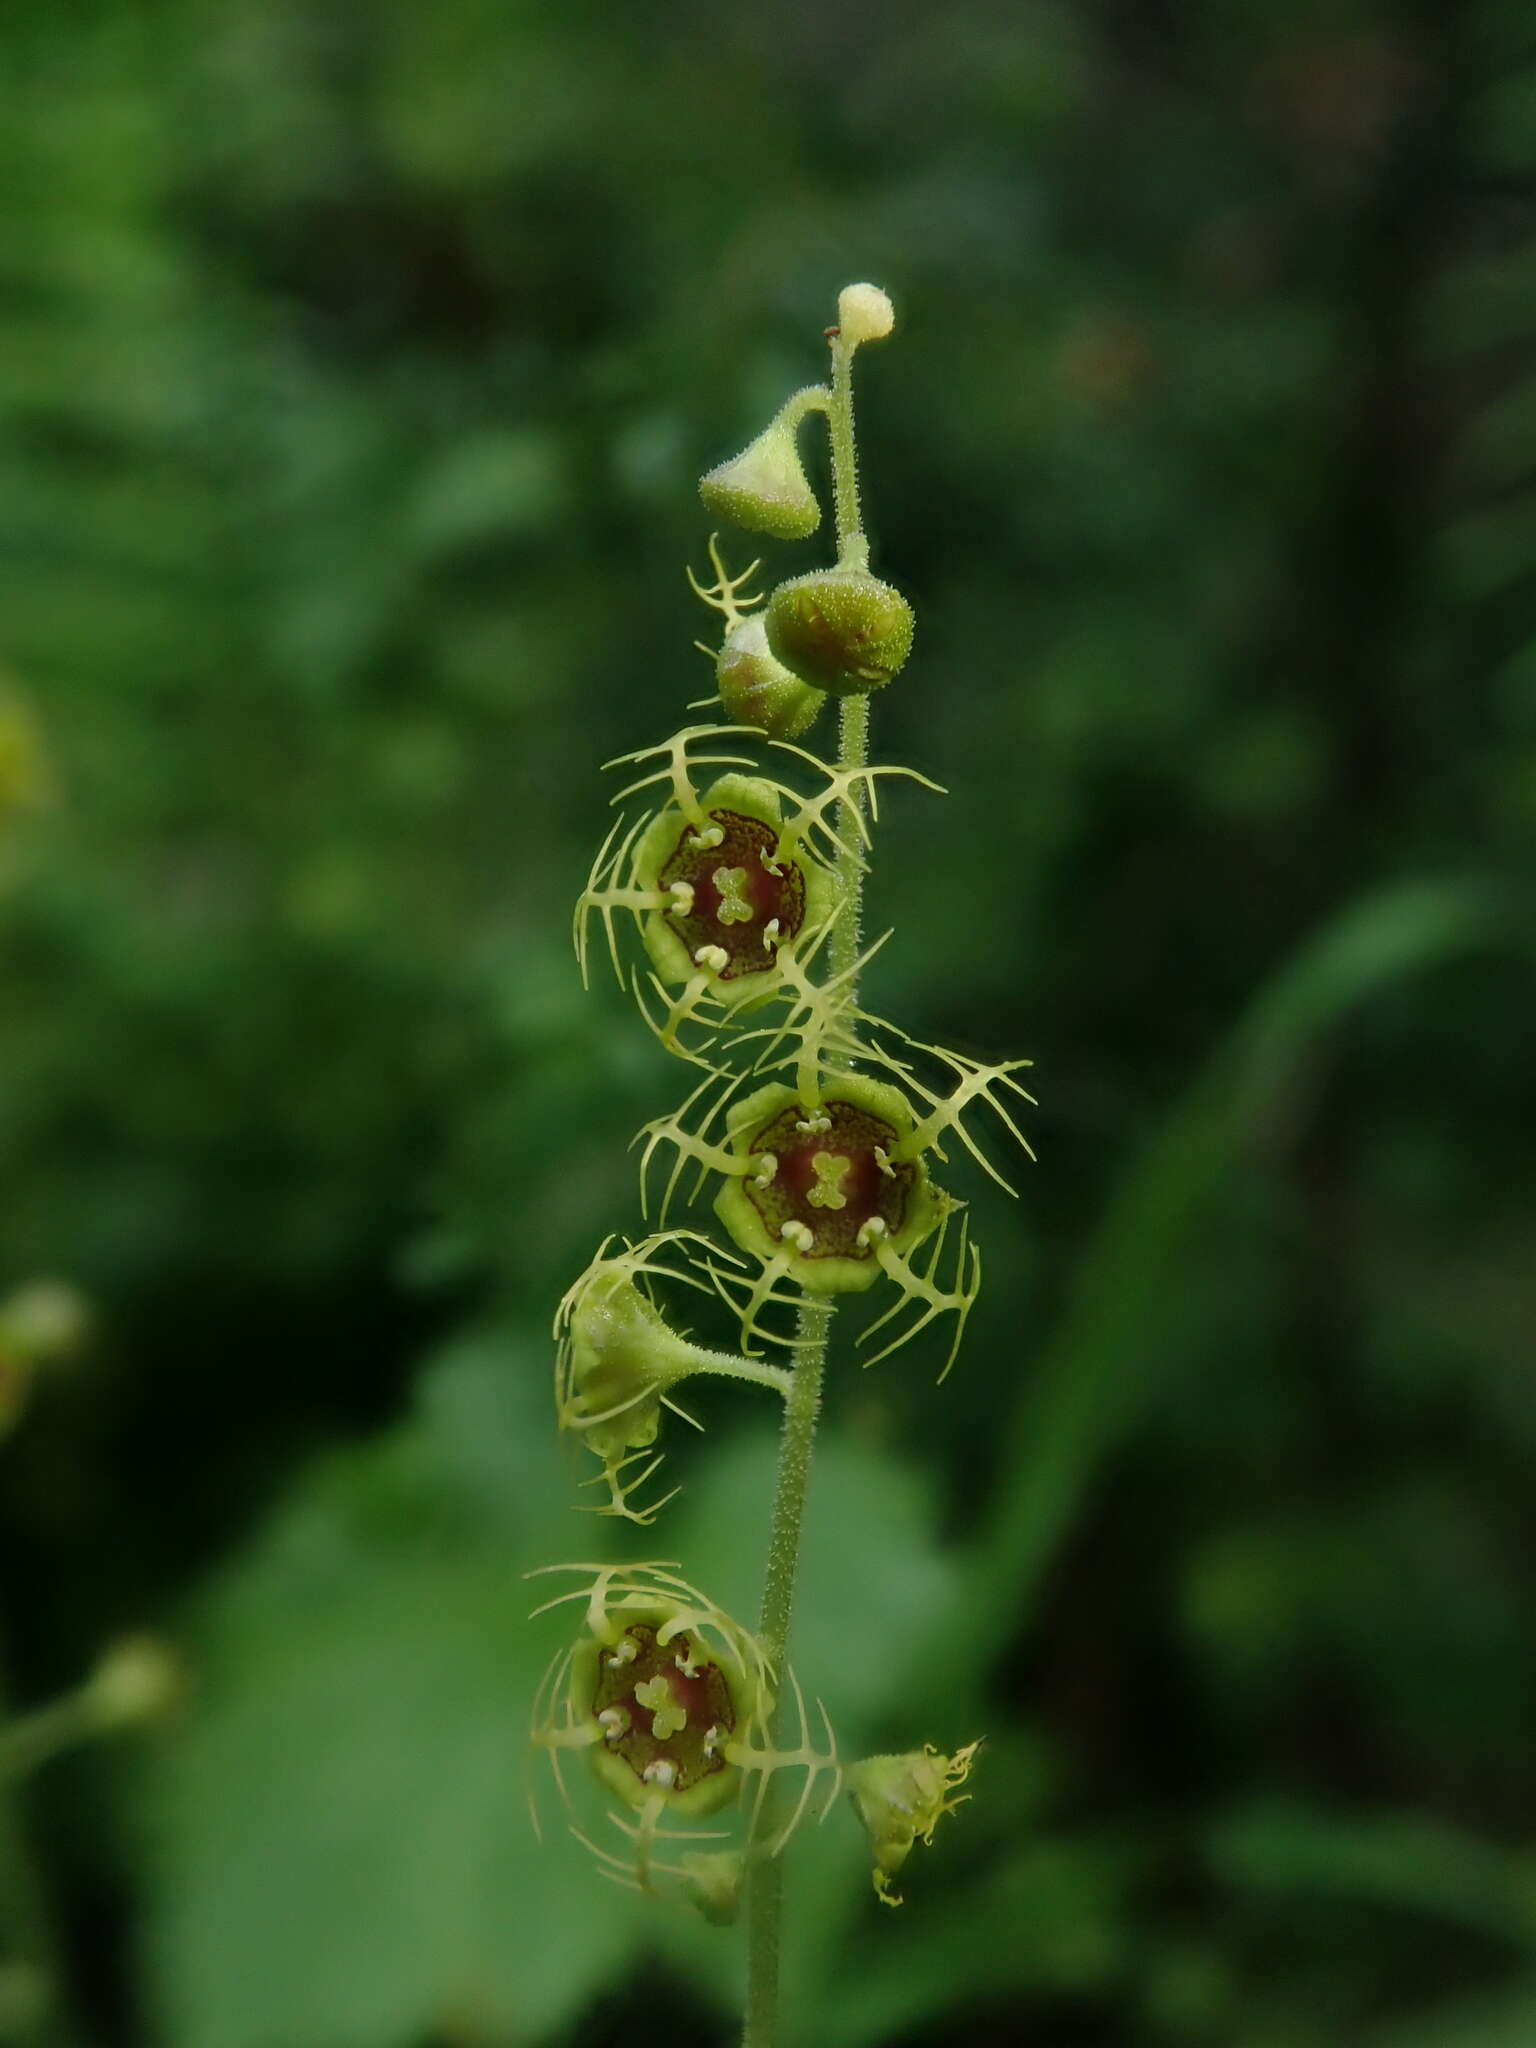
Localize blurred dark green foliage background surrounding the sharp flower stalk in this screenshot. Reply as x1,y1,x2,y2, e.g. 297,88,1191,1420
0,0,1536,2048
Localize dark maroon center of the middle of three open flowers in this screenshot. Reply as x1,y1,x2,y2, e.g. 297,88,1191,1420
743,1100,918,1260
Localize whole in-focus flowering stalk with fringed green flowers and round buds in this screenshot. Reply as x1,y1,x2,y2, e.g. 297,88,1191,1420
532,285,1030,2048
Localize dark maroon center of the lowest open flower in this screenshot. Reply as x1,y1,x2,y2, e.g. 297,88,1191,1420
592,1622,735,1792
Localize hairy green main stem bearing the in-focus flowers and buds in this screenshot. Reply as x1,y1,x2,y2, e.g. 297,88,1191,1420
741,323,868,2048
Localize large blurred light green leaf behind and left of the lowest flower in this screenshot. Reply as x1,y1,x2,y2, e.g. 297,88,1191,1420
131,1339,637,2048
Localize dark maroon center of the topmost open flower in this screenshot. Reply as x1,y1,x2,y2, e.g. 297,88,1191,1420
659,811,805,981
